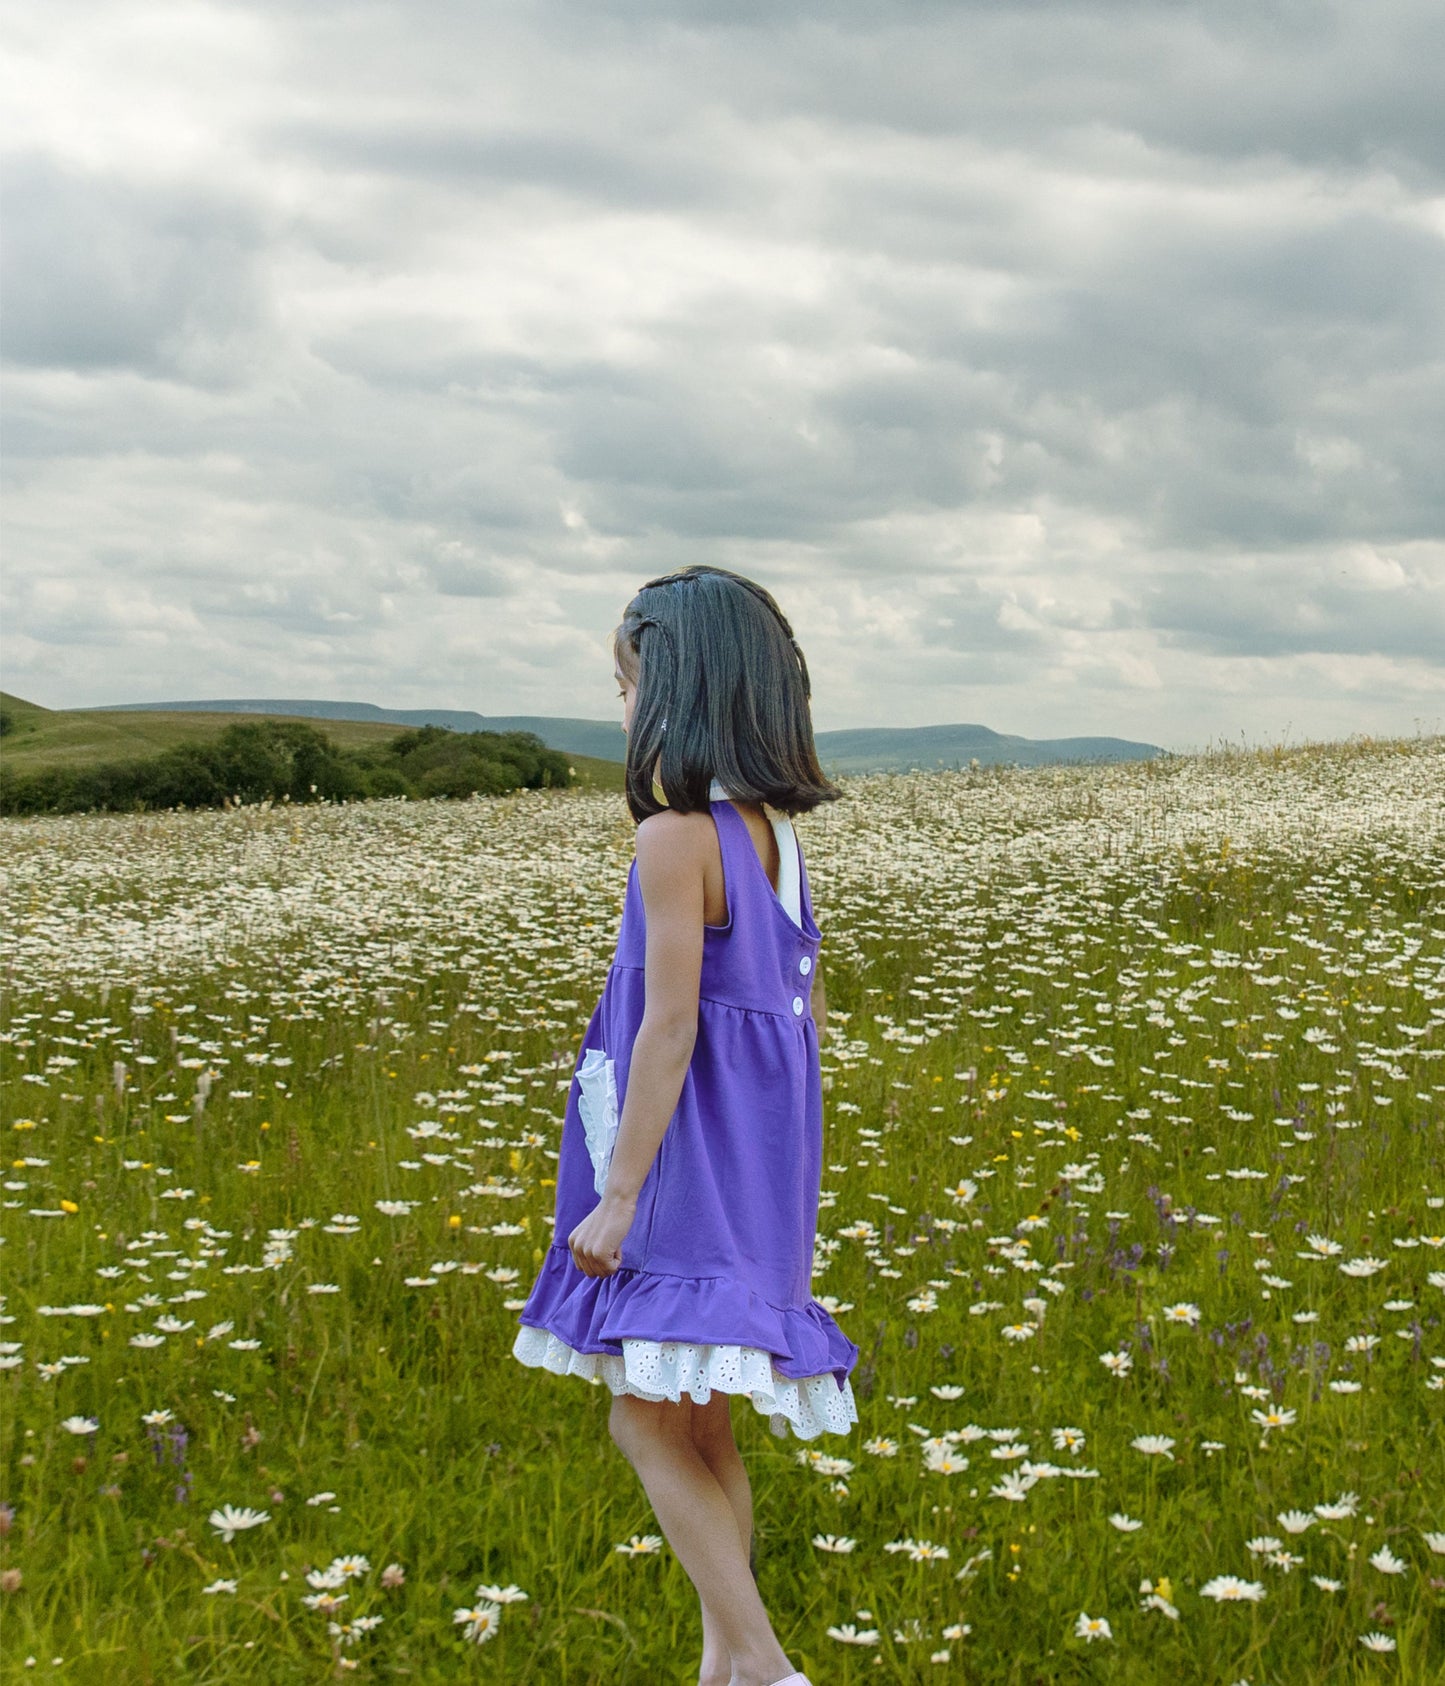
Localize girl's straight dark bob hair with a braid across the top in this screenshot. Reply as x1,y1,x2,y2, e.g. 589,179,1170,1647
612,563,843,824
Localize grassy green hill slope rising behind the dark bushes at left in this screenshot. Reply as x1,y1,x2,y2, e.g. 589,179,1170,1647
0,691,622,791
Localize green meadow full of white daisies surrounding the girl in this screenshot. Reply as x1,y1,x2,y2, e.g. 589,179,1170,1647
0,738,1445,1686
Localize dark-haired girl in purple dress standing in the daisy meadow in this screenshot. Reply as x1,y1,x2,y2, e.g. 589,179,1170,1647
513,566,858,1686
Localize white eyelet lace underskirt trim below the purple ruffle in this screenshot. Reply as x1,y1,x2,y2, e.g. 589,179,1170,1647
513,1324,858,1440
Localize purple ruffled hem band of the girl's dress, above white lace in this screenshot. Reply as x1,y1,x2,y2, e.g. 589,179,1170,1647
518,1243,858,1389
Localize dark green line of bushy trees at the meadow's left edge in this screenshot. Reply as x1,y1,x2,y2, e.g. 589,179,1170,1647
0,720,572,814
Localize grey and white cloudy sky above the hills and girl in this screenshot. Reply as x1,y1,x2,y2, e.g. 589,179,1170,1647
0,0,1445,750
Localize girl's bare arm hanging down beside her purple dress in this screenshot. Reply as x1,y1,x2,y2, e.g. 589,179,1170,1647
568,811,712,1276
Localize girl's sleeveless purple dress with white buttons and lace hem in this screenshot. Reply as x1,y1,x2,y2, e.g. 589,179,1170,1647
513,781,858,1440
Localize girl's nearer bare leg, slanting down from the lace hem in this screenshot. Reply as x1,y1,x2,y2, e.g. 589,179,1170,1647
607,1393,792,1686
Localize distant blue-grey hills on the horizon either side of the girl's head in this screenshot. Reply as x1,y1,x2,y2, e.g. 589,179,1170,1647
88,698,1168,774
